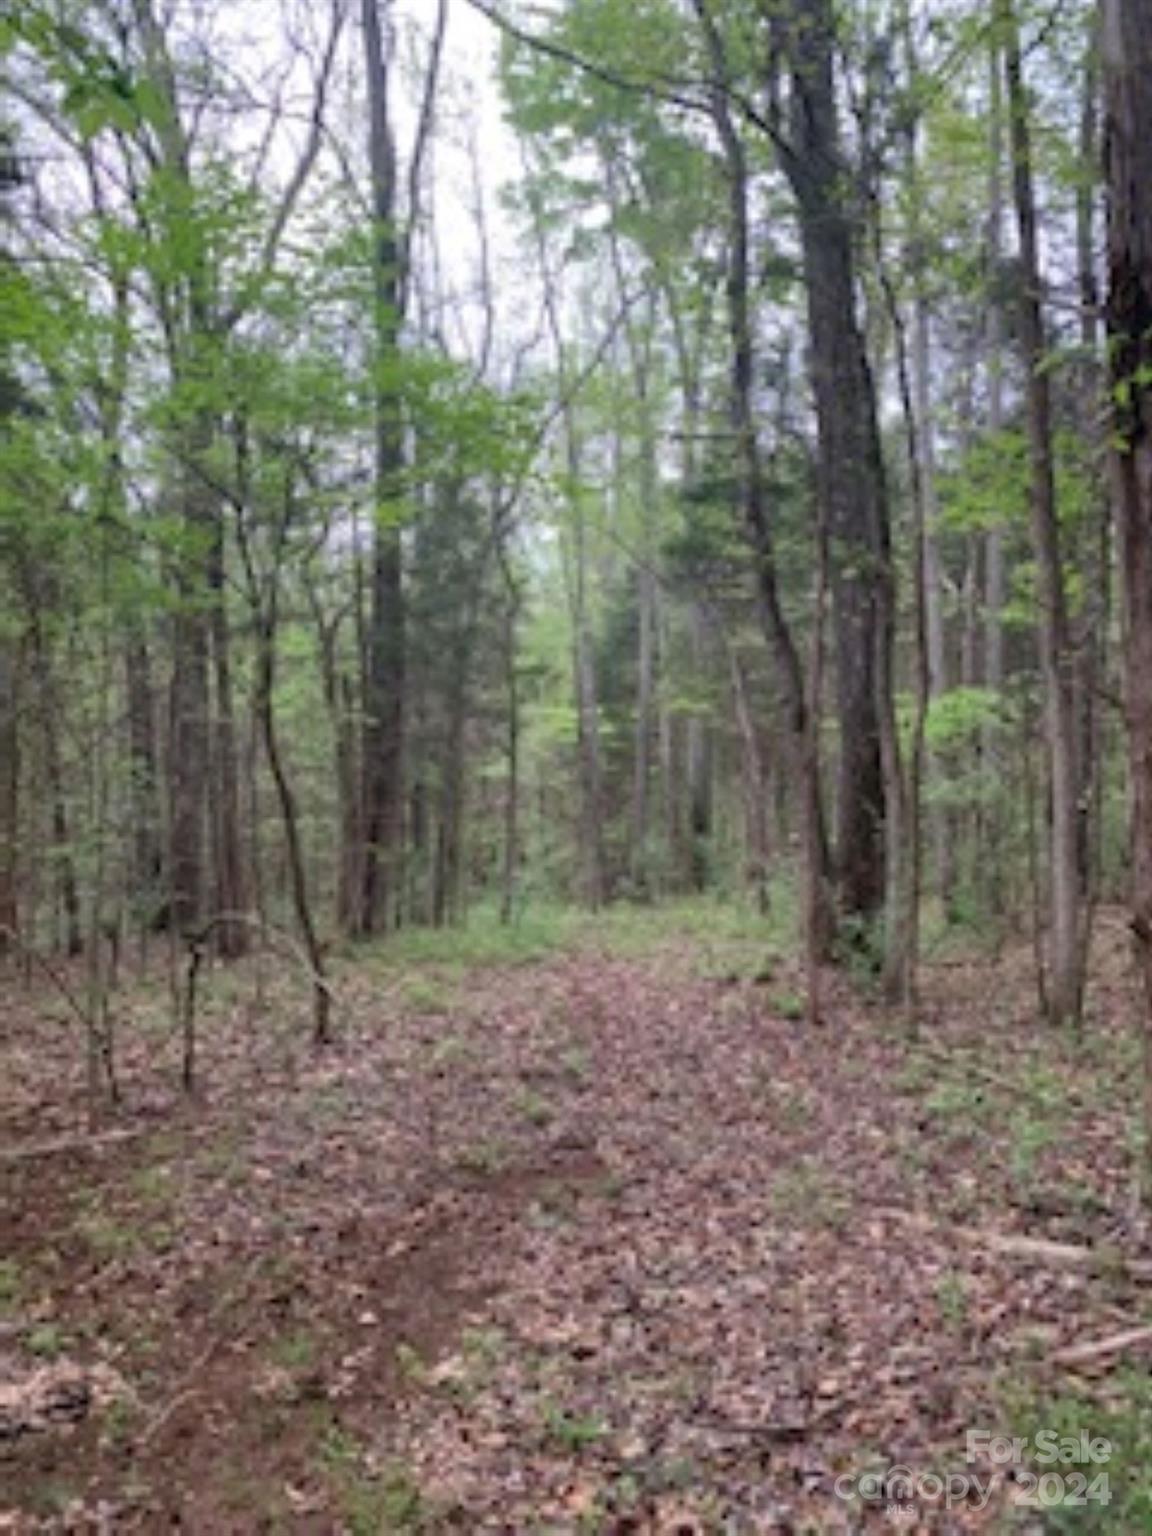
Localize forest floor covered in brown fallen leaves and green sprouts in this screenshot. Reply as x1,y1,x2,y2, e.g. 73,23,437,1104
0,912,1152,1536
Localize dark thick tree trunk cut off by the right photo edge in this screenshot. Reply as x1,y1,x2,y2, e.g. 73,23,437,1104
1101,0,1152,1204
